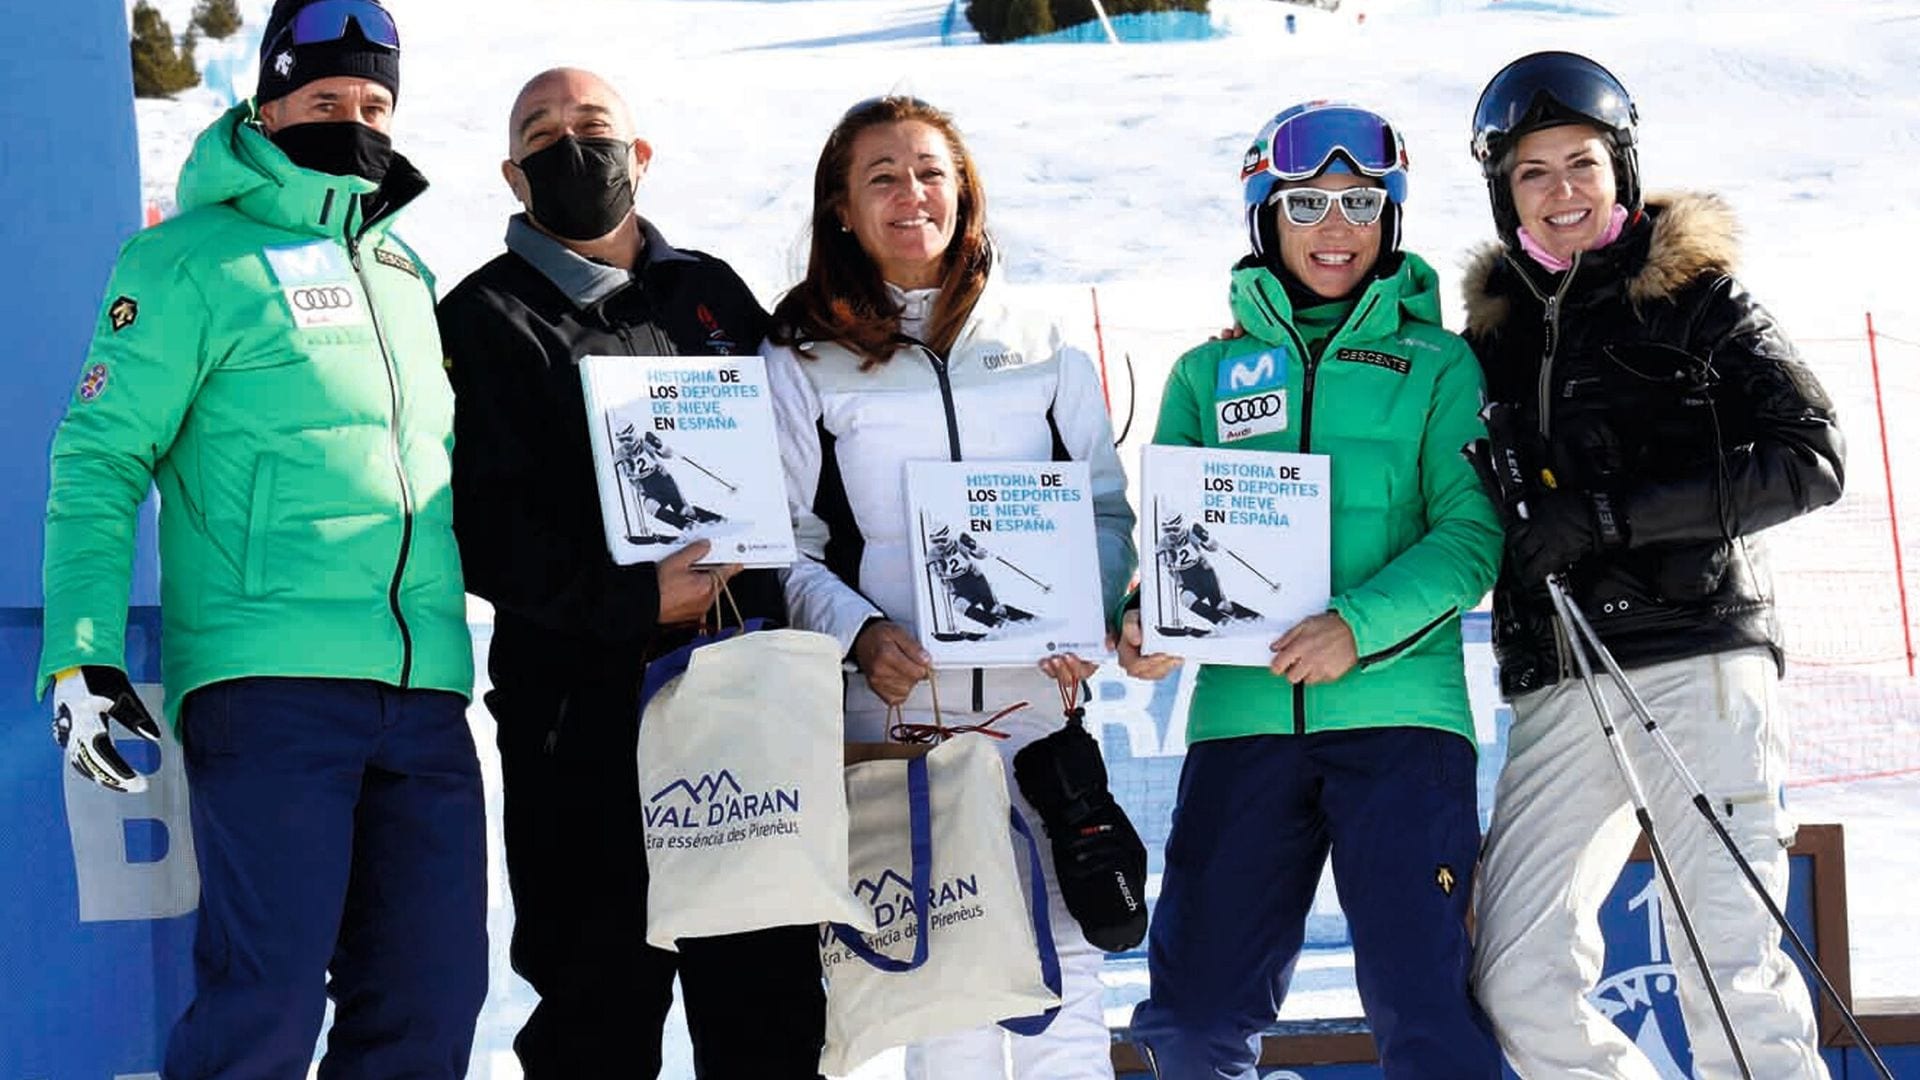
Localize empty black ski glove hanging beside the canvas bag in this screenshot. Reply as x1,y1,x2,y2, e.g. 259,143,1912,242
1014,707,1146,953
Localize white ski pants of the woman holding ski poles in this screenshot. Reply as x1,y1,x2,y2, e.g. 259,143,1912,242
1475,648,1828,1080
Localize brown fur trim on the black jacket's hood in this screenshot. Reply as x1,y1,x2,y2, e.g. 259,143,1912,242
1461,192,1740,336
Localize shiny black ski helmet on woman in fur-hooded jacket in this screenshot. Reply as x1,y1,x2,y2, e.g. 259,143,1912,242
1473,52,1642,246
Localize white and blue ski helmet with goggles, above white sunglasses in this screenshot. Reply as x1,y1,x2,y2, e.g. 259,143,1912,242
1240,102,1407,261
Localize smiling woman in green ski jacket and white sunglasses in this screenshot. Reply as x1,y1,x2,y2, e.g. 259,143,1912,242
1119,102,1501,1080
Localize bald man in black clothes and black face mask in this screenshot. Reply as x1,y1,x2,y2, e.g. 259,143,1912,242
440,69,826,1080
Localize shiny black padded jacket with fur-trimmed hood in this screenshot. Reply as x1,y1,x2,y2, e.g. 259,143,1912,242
1465,183,1843,694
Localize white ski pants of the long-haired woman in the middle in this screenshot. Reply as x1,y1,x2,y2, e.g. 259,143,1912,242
847,671,1114,1080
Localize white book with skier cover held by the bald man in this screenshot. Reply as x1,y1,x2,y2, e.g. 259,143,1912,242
580,356,795,567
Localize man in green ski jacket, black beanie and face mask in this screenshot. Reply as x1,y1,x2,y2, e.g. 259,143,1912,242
38,0,486,1080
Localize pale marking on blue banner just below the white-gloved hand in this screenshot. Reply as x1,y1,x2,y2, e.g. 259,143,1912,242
61,682,200,922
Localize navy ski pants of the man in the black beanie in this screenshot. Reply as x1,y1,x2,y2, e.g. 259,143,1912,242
165,678,488,1080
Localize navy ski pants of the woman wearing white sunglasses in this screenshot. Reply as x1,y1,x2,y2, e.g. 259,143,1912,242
1133,728,1500,1080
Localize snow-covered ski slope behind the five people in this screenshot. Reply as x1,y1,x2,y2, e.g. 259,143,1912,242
140,0,1920,1076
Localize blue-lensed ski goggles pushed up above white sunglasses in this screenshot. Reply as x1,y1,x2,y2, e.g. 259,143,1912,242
1240,102,1407,206
